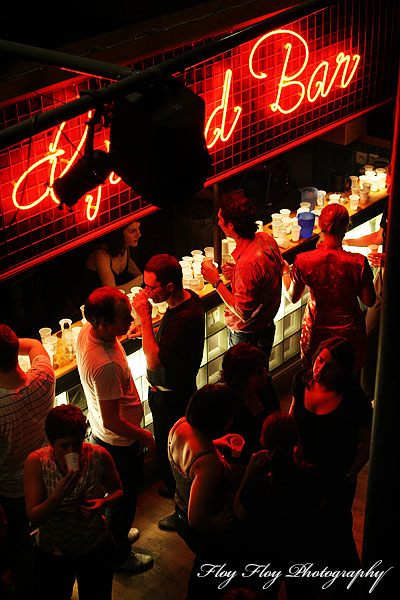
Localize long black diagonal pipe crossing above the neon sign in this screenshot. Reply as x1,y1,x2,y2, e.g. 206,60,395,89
0,0,337,150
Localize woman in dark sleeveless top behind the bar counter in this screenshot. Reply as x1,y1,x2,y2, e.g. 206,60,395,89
84,221,143,299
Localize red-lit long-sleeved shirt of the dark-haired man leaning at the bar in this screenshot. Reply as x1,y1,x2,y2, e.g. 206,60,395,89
225,232,283,333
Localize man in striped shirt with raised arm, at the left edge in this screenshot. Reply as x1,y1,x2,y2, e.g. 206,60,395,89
0,325,55,600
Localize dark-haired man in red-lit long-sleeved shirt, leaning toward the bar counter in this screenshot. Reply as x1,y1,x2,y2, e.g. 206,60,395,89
202,192,284,360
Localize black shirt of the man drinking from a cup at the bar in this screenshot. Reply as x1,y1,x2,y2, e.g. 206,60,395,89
147,290,204,392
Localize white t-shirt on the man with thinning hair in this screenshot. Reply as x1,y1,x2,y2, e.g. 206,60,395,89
76,323,143,446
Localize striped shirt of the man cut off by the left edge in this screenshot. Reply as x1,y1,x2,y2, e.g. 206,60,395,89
0,356,55,498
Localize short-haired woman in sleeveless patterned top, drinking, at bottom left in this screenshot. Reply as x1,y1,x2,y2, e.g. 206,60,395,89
24,404,122,600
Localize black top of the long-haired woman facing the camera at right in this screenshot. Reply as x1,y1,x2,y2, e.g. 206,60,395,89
292,369,372,476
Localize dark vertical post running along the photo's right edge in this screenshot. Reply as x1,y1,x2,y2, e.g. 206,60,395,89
362,63,400,600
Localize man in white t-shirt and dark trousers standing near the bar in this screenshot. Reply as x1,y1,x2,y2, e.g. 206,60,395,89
76,287,155,573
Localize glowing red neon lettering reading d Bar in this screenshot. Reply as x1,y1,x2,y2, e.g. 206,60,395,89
205,29,360,148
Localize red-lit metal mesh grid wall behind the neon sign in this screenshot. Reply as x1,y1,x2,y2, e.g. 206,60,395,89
0,0,399,279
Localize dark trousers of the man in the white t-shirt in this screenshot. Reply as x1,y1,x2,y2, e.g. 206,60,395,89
89,434,143,564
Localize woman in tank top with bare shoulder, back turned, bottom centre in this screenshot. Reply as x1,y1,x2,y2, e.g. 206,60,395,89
168,384,239,599
